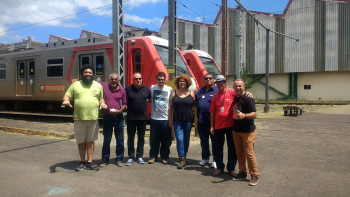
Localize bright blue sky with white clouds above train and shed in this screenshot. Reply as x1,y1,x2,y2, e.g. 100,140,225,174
0,0,289,43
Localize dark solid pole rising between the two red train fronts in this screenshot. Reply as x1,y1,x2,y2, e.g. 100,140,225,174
167,0,177,80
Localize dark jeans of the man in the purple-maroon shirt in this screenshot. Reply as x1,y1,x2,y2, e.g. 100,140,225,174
102,114,124,162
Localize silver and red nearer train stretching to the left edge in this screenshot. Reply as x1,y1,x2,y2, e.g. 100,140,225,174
0,36,198,112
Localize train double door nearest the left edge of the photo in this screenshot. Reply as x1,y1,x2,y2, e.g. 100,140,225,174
16,60,35,96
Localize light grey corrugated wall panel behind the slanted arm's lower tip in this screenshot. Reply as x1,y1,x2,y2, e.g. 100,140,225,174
284,0,315,73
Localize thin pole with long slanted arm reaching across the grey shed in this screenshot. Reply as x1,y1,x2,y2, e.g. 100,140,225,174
235,0,299,113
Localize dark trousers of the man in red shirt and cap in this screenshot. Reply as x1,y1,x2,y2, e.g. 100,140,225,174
214,127,237,172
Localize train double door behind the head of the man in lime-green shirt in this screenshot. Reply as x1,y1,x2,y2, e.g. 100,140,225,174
79,53,105,81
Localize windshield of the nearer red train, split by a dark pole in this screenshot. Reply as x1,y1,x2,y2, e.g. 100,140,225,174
154,45,193,77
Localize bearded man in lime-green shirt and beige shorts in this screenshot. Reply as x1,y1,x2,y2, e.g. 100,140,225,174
62,65,107,171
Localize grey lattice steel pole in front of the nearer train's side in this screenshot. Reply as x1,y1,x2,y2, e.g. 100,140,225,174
112,0,125,87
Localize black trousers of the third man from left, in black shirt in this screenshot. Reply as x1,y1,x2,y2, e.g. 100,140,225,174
127,120,146,159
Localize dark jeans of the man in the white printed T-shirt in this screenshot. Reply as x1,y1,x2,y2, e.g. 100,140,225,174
149,119,171,159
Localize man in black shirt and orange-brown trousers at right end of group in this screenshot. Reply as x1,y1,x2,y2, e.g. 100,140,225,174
233,79,259,186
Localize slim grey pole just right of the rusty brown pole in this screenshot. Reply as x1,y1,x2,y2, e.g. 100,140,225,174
235,0,242,79
